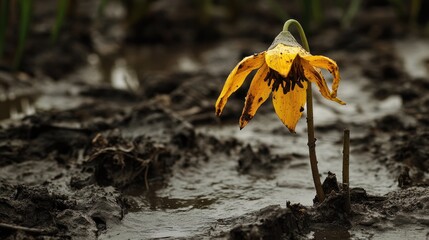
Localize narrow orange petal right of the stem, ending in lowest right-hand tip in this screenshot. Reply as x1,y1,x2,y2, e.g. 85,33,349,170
301,59,346,105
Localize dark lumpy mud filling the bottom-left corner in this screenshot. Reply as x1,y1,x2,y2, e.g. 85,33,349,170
0,181,123,239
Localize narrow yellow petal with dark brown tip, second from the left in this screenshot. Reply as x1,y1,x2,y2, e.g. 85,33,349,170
240,64,271,129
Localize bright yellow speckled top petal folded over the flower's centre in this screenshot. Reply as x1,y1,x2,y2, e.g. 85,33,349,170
265,43,302,77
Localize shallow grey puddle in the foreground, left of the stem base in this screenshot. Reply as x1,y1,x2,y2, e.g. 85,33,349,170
101,149,313,239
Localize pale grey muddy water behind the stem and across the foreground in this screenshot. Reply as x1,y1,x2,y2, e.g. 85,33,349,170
100,47,401,239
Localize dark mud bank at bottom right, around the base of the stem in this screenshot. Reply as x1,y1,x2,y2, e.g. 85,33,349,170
211,173,429,239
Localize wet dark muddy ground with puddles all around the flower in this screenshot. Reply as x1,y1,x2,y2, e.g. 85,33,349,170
0,1,429,239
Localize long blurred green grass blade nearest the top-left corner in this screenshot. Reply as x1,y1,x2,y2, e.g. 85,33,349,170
13,0,33,70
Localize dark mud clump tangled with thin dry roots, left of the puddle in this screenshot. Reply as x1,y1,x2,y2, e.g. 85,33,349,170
86,135,177,189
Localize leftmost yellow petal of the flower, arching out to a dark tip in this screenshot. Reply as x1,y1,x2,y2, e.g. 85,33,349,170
215,52,265,116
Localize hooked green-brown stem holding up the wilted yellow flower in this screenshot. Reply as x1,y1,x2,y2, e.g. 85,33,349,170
283,19,325,202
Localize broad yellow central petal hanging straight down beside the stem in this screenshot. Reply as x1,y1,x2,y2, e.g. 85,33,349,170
273,81,308,133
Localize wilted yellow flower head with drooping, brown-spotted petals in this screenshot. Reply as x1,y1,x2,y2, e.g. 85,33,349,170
216,31,345,132
